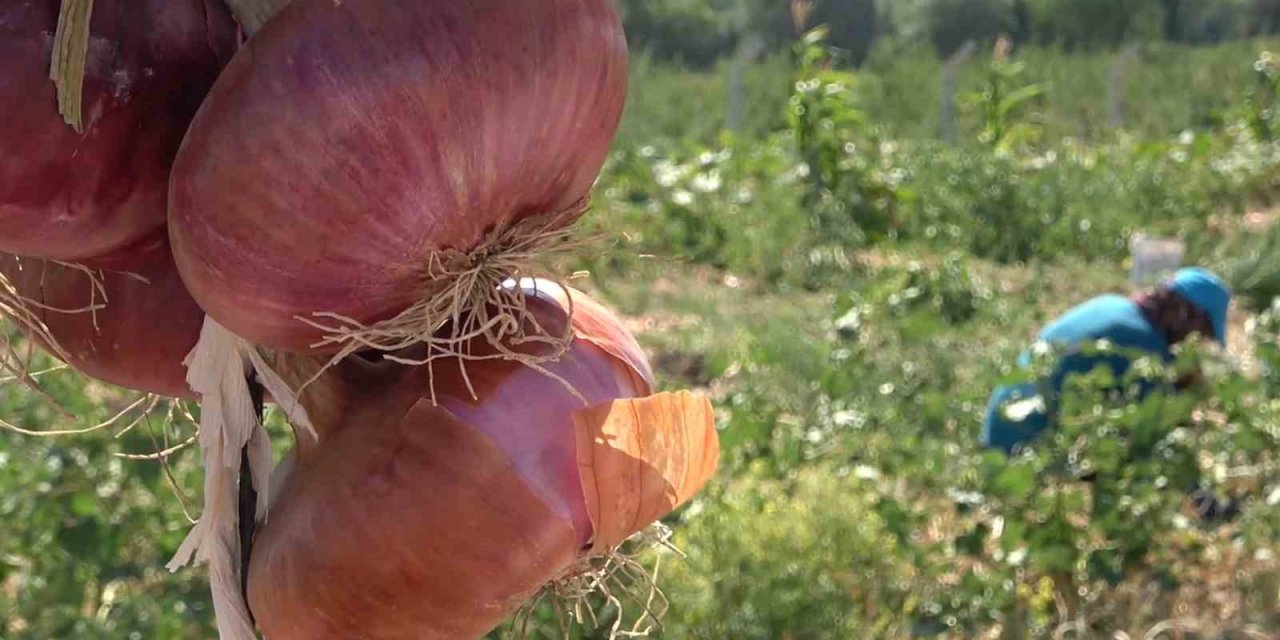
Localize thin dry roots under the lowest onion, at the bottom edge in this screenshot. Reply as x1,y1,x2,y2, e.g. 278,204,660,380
508,522,682,640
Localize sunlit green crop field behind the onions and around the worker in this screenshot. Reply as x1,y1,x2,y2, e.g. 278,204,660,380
0,30,1280,640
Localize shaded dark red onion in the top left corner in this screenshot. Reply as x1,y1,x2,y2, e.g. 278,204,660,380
0,0,238,261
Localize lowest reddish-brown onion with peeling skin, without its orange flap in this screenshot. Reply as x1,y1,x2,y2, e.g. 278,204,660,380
250,286,652,640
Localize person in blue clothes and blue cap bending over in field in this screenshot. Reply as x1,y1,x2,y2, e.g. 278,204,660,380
982,268,1231,519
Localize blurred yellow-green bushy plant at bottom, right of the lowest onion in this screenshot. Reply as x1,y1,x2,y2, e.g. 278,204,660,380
667,467,911,640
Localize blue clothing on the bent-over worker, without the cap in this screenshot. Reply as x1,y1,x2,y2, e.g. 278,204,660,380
982,294,1172,453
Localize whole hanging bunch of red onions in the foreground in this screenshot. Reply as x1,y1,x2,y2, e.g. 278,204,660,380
0,0,718,640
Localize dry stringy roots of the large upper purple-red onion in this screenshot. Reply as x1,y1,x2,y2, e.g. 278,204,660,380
298,198,588,402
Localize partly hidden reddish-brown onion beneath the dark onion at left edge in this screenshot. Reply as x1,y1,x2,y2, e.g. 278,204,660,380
0,230,204,398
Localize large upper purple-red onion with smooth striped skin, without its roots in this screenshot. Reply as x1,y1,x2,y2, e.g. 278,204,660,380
169,0,627,351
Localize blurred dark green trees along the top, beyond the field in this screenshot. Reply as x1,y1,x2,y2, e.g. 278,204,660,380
617,0,1280,68
